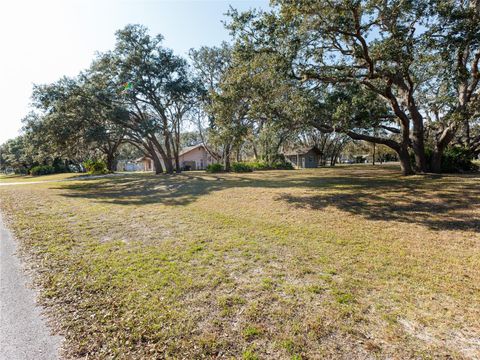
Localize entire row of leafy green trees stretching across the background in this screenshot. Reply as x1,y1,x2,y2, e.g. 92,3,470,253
0,0,480,175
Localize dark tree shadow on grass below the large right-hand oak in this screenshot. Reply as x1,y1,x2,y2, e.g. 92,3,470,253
278,184,480,231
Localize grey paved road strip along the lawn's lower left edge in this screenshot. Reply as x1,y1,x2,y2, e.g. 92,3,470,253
0,214,62,360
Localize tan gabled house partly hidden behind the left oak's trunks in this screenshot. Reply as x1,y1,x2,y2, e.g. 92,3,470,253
129,144,216,171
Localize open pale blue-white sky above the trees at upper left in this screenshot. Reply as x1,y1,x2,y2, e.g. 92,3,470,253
0,0,268,144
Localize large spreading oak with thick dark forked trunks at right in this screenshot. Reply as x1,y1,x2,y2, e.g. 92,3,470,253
229,0,480,174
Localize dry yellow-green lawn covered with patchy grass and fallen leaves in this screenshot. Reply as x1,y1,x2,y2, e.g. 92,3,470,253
0,166,480,359
